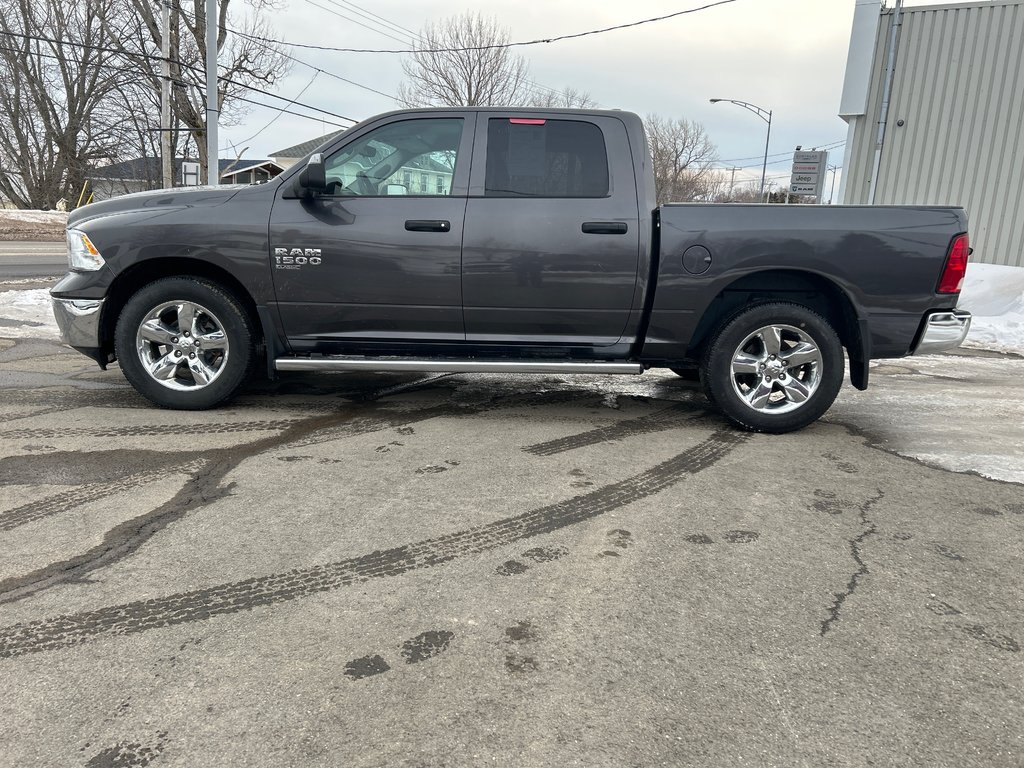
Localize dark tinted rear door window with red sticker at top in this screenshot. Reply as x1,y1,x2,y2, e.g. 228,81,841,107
484,118,608,198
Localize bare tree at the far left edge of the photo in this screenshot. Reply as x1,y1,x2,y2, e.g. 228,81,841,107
0,0,122,208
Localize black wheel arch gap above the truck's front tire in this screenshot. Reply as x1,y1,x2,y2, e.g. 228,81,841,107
100,256,263,355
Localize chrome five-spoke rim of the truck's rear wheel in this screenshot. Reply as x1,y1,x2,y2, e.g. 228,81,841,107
729,325,822,414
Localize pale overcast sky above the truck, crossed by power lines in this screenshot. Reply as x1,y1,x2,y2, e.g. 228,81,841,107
211,0,962,192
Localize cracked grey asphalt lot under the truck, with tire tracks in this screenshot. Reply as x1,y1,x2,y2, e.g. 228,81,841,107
0,339,1024,768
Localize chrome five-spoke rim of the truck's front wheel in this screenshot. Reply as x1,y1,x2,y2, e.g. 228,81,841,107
135,301,229,392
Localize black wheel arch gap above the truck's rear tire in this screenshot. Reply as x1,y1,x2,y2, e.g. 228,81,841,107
687,269,870,389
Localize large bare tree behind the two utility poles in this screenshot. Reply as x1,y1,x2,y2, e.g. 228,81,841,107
122,0,289,183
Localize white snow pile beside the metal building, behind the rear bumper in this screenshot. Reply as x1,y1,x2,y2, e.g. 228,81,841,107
957,264,1024,354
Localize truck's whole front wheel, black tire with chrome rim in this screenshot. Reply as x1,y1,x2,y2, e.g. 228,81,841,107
114,278,256,411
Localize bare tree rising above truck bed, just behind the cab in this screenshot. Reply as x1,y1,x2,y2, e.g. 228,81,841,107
644,115,720,205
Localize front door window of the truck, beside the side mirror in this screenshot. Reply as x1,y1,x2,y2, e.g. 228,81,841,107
325,118,462,197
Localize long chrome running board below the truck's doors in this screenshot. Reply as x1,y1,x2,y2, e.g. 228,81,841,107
273,357,644,376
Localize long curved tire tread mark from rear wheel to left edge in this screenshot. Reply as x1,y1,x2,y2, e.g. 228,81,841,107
0,427,748,658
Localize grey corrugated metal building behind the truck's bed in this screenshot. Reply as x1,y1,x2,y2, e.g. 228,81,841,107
840,0,1024,266
